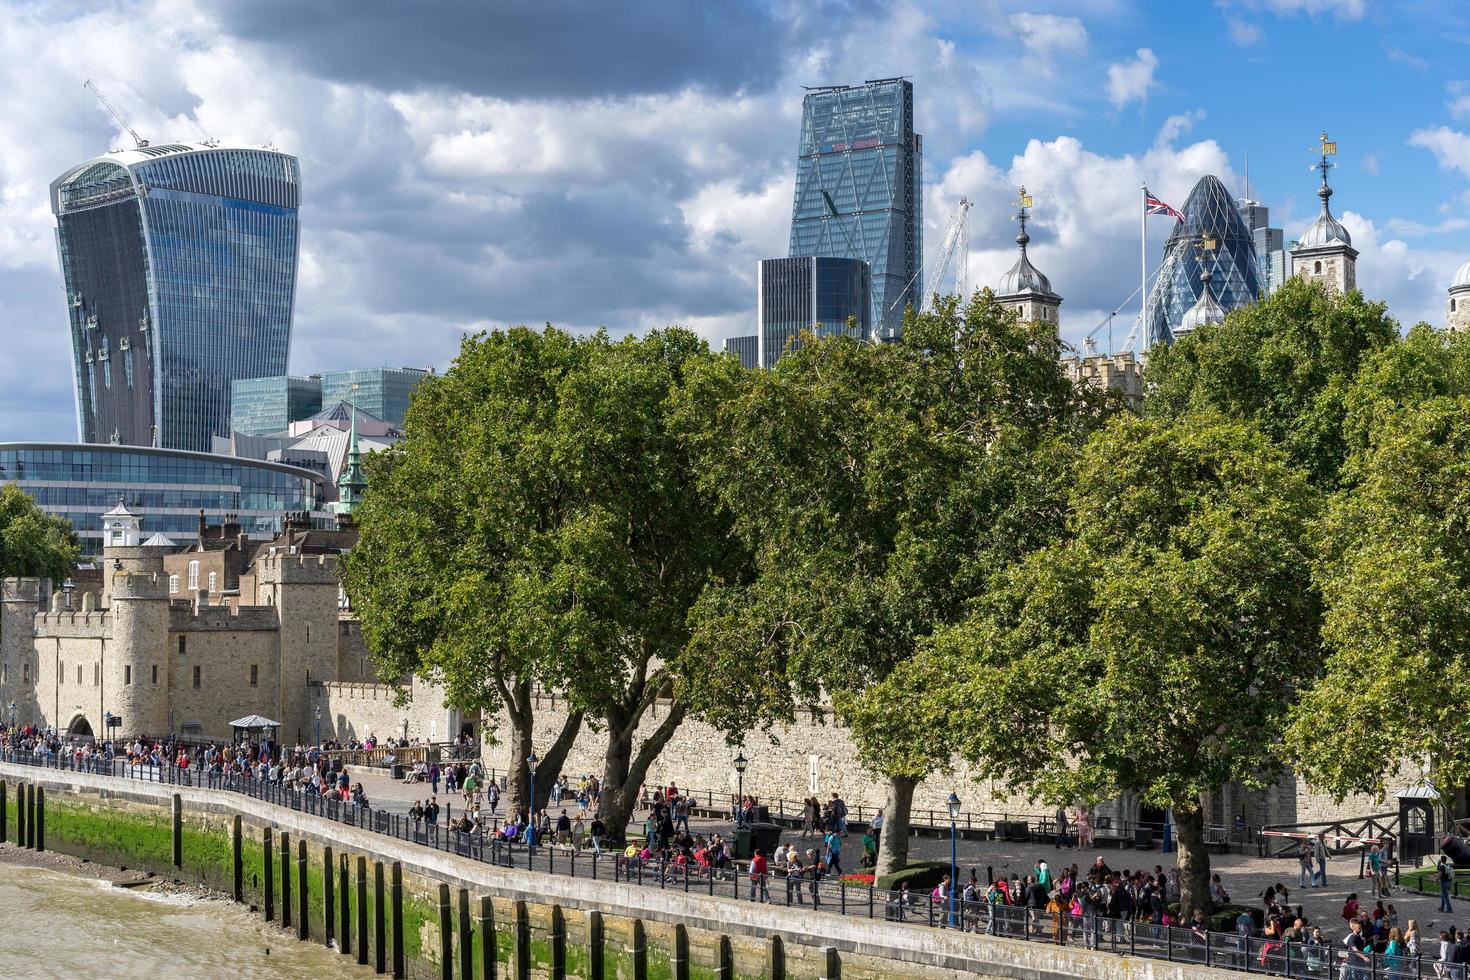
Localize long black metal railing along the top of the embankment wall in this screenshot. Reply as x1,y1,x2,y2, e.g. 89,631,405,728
0,752,1434,980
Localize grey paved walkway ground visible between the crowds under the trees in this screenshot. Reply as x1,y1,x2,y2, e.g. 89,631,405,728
351,768,1470,940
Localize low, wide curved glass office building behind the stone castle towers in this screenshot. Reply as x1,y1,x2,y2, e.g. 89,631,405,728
0,442,331,554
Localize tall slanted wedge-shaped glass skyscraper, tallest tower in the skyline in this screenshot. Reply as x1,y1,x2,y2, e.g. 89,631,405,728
791,78,923,339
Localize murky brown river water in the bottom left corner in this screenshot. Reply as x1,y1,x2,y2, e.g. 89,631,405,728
0,865,372,980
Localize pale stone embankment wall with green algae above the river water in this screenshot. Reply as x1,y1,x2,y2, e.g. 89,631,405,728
0,764,1258,980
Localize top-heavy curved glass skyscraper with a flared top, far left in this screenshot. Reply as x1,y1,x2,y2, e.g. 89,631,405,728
51,144,300,452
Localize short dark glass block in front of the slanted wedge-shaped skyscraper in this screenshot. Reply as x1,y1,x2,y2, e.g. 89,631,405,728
756,257,872,367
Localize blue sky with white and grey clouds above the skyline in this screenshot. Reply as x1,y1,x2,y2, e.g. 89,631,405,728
0,0,1470,441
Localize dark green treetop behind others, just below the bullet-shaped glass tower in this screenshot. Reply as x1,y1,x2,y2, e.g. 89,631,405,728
1144,279,1398,488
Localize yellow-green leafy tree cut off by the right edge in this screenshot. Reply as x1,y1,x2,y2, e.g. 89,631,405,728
1288,399,1470,799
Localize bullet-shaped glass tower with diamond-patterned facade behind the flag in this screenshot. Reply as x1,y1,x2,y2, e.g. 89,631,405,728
1148,176,1261,345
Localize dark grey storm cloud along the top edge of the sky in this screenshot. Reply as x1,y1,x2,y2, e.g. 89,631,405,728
206,0,792,98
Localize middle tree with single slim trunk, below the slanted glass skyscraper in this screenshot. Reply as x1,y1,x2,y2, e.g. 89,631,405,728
685,294,1097,873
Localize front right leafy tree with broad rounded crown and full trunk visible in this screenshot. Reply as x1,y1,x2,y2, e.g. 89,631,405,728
914,416,1319,914
